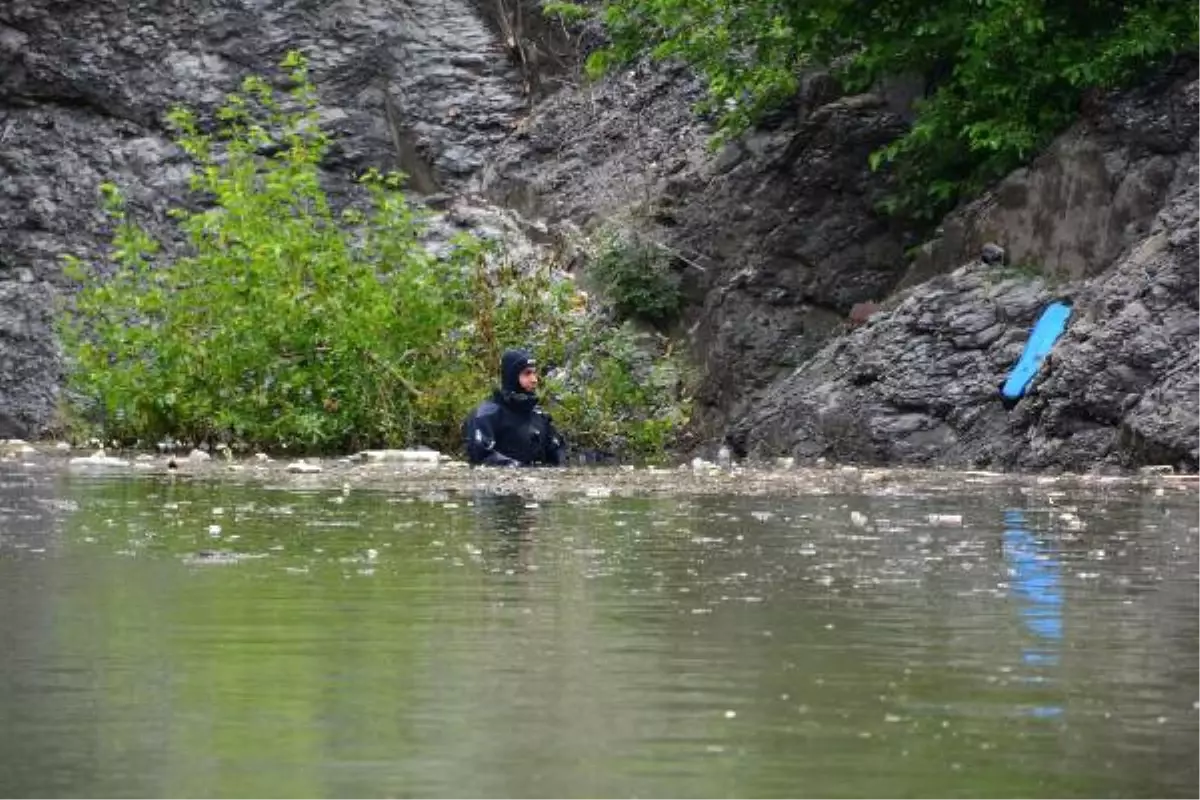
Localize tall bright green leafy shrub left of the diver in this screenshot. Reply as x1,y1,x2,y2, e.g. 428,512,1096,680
62,55,478,446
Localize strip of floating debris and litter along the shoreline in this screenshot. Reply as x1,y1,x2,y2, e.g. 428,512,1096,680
0,441,1200,501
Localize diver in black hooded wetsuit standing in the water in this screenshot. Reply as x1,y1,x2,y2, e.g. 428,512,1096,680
463,350,566,467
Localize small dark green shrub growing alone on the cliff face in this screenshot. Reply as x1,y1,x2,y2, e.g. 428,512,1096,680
588,231,683,324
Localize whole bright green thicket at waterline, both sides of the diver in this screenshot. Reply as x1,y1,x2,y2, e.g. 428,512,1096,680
60,54,691,460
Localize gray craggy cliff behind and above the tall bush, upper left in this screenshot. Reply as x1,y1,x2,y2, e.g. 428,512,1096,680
0,0,545,437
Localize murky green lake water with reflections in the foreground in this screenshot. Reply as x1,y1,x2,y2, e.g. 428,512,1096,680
0,471,1200,800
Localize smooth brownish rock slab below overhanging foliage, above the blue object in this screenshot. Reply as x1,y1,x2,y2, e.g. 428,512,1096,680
904,65,1200,285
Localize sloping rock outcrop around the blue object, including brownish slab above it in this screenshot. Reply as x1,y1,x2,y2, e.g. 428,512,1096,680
730,62,1200,469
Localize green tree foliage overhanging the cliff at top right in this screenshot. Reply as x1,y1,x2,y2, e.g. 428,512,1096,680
588,0,1200,221
